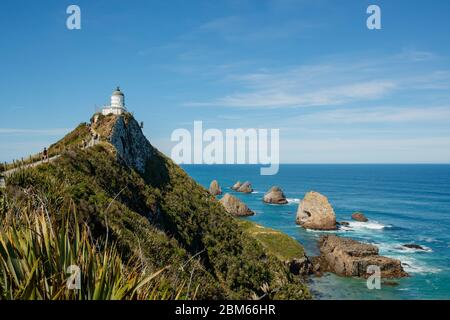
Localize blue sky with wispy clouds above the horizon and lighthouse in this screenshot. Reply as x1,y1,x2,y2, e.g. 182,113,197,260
0,0,450,163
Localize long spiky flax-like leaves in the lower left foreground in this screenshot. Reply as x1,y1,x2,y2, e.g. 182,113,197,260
0,189,186,300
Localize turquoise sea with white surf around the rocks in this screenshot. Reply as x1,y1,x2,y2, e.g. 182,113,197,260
183,165,450,299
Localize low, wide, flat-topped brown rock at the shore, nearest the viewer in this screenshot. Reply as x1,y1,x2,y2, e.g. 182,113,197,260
319,235,408,278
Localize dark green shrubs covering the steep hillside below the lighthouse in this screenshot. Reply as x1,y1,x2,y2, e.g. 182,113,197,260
0,117,310,299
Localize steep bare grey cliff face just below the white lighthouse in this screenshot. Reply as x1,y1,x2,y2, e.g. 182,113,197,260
109,117,155,174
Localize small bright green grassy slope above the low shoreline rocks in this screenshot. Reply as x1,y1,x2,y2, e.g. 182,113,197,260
239,220,305,261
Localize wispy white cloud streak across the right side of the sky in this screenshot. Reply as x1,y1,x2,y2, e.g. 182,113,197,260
184,52,450,108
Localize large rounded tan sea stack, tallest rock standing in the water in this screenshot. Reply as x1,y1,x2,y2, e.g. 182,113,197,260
296,191,336,230
